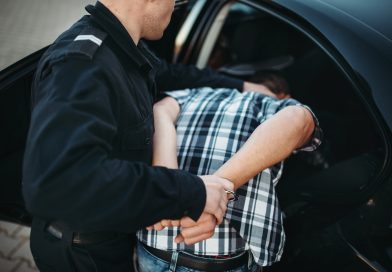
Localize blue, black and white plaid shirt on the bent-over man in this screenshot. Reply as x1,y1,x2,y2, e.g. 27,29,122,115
137,88,321,266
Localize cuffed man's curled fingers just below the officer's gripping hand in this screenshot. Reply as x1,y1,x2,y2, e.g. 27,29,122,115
174,213,217,245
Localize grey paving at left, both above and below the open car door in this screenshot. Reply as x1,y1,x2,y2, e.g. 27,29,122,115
0,0,95,272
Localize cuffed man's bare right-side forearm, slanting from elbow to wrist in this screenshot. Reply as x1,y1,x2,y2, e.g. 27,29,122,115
214,106,315,189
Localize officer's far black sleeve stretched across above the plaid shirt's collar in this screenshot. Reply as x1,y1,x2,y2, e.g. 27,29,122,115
156,60,244,92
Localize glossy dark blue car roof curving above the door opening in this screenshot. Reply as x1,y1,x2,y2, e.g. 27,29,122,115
276,0,392,130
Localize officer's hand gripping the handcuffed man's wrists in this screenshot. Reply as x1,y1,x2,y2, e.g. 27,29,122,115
200,175,234,224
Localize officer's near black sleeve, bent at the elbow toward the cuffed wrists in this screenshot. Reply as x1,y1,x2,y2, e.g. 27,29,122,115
23,58,206,232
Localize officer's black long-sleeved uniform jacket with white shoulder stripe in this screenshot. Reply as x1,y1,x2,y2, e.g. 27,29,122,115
23,2,242,232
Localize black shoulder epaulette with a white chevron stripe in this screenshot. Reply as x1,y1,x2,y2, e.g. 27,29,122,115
68,26,107,59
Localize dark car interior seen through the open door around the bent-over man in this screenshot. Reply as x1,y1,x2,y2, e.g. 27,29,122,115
165,2,385,234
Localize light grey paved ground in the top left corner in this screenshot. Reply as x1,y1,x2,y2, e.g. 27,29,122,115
0,0,95,70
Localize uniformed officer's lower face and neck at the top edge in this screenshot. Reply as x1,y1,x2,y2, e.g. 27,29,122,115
100,0,175,44
